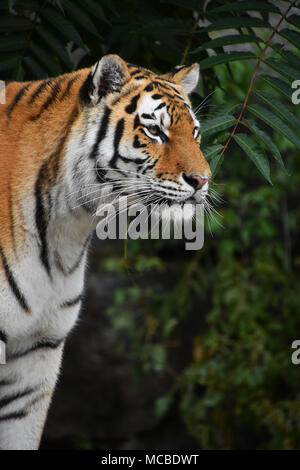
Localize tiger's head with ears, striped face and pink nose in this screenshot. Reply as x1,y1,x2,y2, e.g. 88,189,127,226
71,55,211,215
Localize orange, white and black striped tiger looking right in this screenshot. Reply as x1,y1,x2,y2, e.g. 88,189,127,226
0,54,211,450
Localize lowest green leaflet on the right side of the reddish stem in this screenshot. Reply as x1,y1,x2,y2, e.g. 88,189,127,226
234,133,272,184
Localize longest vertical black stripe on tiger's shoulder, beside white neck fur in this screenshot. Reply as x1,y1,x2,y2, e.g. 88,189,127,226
35,162,50,276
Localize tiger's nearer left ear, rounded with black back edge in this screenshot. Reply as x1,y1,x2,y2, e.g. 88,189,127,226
81,54,130,104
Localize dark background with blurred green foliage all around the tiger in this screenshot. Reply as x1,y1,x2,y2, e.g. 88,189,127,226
0,0,300,449
